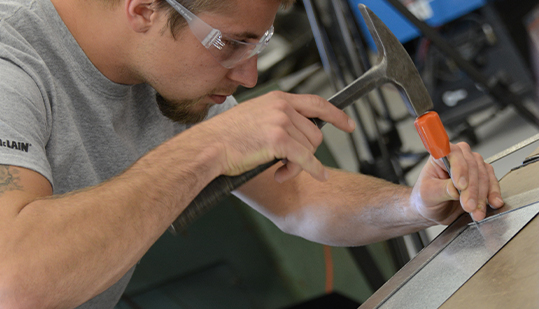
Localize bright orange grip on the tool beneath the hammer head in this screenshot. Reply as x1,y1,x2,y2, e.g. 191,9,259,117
414,112,451,159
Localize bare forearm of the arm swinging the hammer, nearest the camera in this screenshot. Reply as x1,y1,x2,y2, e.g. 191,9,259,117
0,129,223,307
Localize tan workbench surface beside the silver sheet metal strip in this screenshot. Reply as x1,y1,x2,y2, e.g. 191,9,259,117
440,148,539,309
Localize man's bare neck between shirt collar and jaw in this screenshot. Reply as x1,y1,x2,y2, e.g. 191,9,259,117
51,0,141,84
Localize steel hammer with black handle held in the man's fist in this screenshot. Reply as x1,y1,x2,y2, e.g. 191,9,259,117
169,4,440,234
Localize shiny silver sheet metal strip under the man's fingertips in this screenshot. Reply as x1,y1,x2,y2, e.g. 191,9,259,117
370,203,539,308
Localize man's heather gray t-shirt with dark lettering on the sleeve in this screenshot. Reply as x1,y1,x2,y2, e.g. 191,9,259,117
0,0,236,308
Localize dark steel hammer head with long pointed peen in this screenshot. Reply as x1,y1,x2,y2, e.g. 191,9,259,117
359,4,433,117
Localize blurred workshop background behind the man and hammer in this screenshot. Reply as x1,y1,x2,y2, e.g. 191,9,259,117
117,0,539,309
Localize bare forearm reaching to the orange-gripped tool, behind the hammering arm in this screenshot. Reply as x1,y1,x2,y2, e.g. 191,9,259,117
239,165,434,246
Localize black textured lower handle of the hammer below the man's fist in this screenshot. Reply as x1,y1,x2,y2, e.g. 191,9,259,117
168,118,325,234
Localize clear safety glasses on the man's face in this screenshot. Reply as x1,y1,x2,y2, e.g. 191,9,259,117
166,0,273,69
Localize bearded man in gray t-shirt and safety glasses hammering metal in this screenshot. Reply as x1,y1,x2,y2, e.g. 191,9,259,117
0,0,503,308
